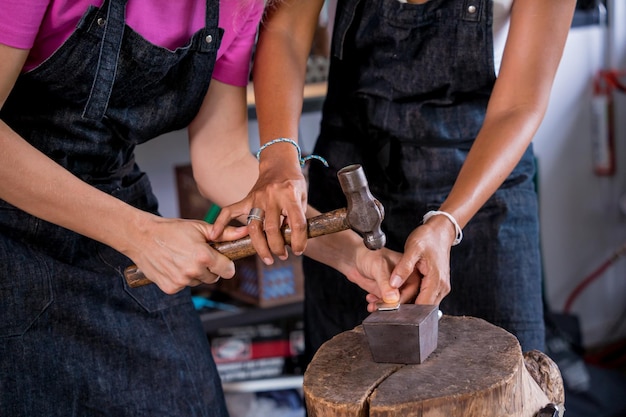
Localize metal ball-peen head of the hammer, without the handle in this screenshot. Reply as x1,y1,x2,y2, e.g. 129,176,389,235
337,164,387,250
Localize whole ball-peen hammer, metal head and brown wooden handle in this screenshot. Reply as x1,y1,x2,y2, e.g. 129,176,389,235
124,164,386,287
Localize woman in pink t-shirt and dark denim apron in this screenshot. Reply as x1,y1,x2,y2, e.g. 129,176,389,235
0,0,398,417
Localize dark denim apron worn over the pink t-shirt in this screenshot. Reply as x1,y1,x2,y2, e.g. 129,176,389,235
0,0,227,417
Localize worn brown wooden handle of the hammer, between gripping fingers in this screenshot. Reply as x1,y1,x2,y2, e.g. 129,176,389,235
124,208,350,288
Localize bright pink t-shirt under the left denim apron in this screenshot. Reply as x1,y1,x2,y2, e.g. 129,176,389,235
0,0,264,86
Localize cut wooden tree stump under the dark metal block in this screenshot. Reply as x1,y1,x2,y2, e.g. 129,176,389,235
304,316,564,417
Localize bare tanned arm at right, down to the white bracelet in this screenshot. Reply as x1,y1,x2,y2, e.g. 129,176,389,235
441,0,576,227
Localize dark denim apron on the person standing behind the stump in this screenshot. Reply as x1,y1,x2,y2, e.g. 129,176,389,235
304,0,544,358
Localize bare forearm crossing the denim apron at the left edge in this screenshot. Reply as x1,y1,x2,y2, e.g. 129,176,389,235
0,122,150,252
